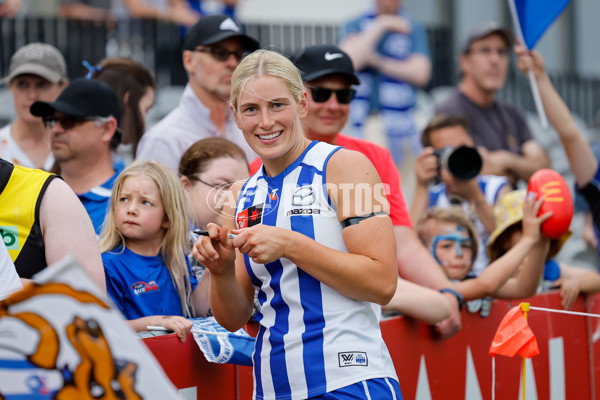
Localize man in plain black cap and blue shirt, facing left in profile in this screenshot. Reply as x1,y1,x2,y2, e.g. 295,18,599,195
31,78,123,234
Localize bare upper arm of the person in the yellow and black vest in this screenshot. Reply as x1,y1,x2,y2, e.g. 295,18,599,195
40,178,106,291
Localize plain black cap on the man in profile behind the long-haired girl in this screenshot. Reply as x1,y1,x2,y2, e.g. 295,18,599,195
30,78,121,143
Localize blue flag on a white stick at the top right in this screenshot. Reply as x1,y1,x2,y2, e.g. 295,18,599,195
513,0,570,49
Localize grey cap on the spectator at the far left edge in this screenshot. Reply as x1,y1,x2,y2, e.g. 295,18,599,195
2,43,67,83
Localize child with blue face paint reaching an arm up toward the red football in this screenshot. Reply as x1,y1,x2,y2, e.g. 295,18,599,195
417,193,552,301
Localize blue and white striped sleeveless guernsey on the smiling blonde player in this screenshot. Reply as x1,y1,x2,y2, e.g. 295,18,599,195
236,141,397,399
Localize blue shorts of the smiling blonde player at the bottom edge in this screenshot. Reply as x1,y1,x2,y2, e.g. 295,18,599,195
311,378,402,400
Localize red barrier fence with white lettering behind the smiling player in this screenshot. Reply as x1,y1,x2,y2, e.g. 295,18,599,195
143,292,600,400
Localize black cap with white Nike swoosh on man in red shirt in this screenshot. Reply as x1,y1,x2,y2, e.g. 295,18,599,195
294,45,360,85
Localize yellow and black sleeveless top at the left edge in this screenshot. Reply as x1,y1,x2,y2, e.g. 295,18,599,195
0,159,56,278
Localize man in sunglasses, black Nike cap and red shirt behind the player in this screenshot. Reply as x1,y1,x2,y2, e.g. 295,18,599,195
250,45,460,336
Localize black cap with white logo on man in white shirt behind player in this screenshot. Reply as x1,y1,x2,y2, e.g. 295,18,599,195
183,14,260,52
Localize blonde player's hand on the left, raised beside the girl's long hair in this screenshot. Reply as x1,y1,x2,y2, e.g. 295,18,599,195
192,223,235,275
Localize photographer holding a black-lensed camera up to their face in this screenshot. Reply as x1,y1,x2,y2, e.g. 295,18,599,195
410,114,512,276
